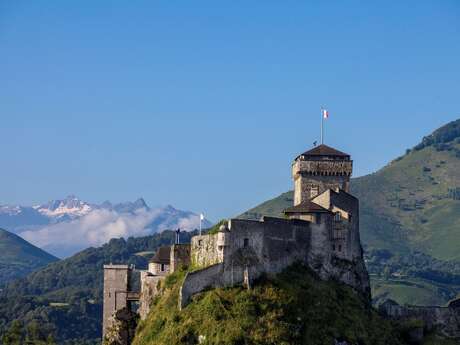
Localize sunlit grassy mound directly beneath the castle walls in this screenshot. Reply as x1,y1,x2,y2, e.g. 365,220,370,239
133,266,403,345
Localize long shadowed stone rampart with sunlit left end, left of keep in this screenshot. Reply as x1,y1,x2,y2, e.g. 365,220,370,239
180,217,311,308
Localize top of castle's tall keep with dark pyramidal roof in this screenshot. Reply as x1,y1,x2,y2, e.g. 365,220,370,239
292,145,353,206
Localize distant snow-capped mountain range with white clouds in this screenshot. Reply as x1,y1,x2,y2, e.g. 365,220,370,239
0,195,212,257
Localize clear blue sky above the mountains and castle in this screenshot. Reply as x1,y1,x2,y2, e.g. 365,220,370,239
0,0,460,220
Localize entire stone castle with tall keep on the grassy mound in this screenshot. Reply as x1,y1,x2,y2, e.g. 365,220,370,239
103,145,370,335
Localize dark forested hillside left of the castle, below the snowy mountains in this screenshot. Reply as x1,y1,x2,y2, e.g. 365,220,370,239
0,231,196,345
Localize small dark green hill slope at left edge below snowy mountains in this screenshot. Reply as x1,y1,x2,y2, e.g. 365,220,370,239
0,229,58,287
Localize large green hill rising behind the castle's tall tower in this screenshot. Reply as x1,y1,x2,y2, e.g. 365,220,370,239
240,120,460,304
